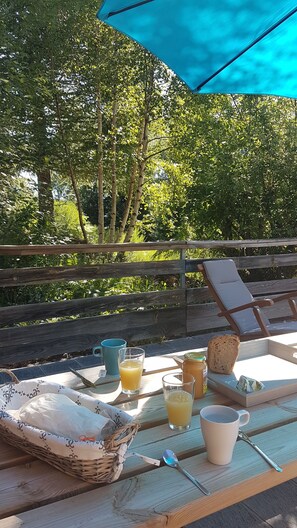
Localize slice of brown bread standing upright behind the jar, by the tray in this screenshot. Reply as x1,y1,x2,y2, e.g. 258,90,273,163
207,334,240,374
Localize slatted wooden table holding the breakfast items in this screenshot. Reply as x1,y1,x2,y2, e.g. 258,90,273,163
0,339,297,528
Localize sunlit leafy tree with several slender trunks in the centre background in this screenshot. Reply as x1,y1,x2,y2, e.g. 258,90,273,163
67,13,173,242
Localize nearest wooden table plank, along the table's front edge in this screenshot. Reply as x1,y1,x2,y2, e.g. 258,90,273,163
1,423,297,528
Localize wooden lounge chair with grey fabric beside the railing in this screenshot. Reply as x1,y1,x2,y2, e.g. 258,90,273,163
198,259,297,339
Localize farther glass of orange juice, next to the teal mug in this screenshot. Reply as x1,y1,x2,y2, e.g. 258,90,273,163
119,347,145,394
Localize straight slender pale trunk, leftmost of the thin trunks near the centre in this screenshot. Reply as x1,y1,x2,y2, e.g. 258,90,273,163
97,86,104,244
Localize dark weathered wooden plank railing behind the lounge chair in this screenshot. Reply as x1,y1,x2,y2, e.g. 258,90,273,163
0,239,297,366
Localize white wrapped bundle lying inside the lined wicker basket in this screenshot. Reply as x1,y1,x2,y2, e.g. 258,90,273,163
18,393,116,441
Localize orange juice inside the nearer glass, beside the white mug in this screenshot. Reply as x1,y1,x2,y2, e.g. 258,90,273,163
165,390,193,427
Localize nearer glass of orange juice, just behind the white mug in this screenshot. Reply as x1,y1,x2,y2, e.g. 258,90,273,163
162,371,195,431
